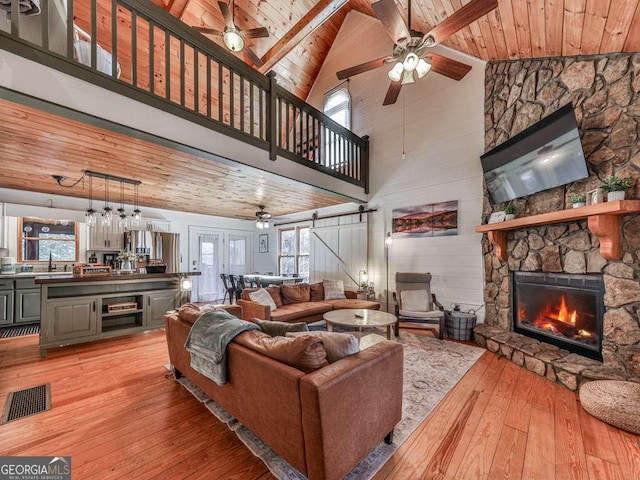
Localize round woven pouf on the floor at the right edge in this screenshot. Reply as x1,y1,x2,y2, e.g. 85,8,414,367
580,380,640,434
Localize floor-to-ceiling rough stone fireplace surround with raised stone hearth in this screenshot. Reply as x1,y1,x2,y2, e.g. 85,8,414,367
474,53,640,390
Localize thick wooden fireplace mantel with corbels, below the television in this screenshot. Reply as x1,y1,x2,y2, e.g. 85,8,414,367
476,200,640,262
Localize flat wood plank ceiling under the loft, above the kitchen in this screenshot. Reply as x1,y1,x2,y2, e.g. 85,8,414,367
0,100,344,219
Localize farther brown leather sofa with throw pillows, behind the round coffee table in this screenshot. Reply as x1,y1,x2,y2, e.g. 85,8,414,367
237,283,380,323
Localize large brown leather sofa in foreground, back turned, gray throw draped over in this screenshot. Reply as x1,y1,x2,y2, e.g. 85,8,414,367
165,306,403,480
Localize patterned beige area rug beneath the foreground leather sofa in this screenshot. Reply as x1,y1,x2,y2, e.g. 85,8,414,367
172,332,484,480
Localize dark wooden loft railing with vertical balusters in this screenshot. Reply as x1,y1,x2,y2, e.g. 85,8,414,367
0,0,368,190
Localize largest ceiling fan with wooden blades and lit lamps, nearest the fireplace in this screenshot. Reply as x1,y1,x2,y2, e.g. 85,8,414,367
337,0,498,105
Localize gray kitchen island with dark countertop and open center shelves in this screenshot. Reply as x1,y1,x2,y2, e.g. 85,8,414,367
35,272,194,357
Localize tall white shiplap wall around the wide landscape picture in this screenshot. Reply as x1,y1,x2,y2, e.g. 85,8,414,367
307,11,484,320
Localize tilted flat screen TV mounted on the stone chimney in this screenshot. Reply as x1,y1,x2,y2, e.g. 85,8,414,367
480,104,589,203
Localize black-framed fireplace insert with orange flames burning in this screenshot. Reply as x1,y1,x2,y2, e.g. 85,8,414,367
511,272,604,361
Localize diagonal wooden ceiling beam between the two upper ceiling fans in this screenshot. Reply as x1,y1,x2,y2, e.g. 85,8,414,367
260,0,349,73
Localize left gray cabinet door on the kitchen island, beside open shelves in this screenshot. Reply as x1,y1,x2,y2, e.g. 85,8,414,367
42,297,98,342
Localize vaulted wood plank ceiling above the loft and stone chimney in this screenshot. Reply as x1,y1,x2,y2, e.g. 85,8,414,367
153,0,640,99
